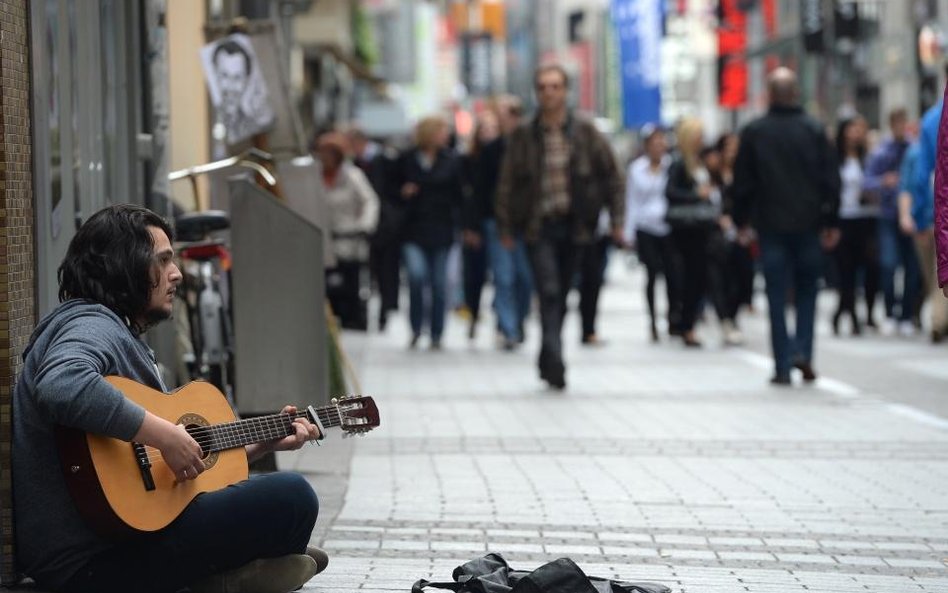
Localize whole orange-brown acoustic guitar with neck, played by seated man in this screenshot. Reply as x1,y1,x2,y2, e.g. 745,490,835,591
56,377,379,539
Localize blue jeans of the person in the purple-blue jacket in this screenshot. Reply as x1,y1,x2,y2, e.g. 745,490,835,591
879,219,921,321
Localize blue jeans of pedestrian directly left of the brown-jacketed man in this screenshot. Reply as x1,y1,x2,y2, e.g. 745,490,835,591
484,219,533,340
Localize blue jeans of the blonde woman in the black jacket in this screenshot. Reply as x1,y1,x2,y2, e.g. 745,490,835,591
402,243,448,342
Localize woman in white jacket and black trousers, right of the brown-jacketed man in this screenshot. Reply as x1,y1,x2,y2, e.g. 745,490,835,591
625,126,681,342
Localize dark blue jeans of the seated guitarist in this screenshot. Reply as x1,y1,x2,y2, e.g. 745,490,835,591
63,472,319,593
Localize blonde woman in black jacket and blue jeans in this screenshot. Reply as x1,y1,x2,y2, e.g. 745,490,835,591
394,116,461,350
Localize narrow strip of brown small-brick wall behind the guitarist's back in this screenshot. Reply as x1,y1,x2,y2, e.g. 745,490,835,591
0,0,35,584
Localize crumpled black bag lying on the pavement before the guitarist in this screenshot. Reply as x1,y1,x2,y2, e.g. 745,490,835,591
411,554,671,593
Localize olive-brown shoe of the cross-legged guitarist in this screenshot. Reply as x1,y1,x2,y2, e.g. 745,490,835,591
190,554,318,593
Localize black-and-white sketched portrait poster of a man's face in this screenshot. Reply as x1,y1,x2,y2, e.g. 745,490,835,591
201,34,275,144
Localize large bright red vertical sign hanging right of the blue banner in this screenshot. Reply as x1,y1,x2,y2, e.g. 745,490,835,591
718,0,747,109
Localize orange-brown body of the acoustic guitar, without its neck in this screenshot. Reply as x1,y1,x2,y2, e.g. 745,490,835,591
57,377,249,538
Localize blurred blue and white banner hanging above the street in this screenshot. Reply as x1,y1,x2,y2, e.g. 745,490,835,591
612,0,663,128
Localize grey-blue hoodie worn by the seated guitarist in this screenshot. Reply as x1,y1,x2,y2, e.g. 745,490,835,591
13,300,165,589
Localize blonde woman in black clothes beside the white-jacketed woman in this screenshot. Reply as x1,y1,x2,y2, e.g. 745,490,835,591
665,117,721,347
